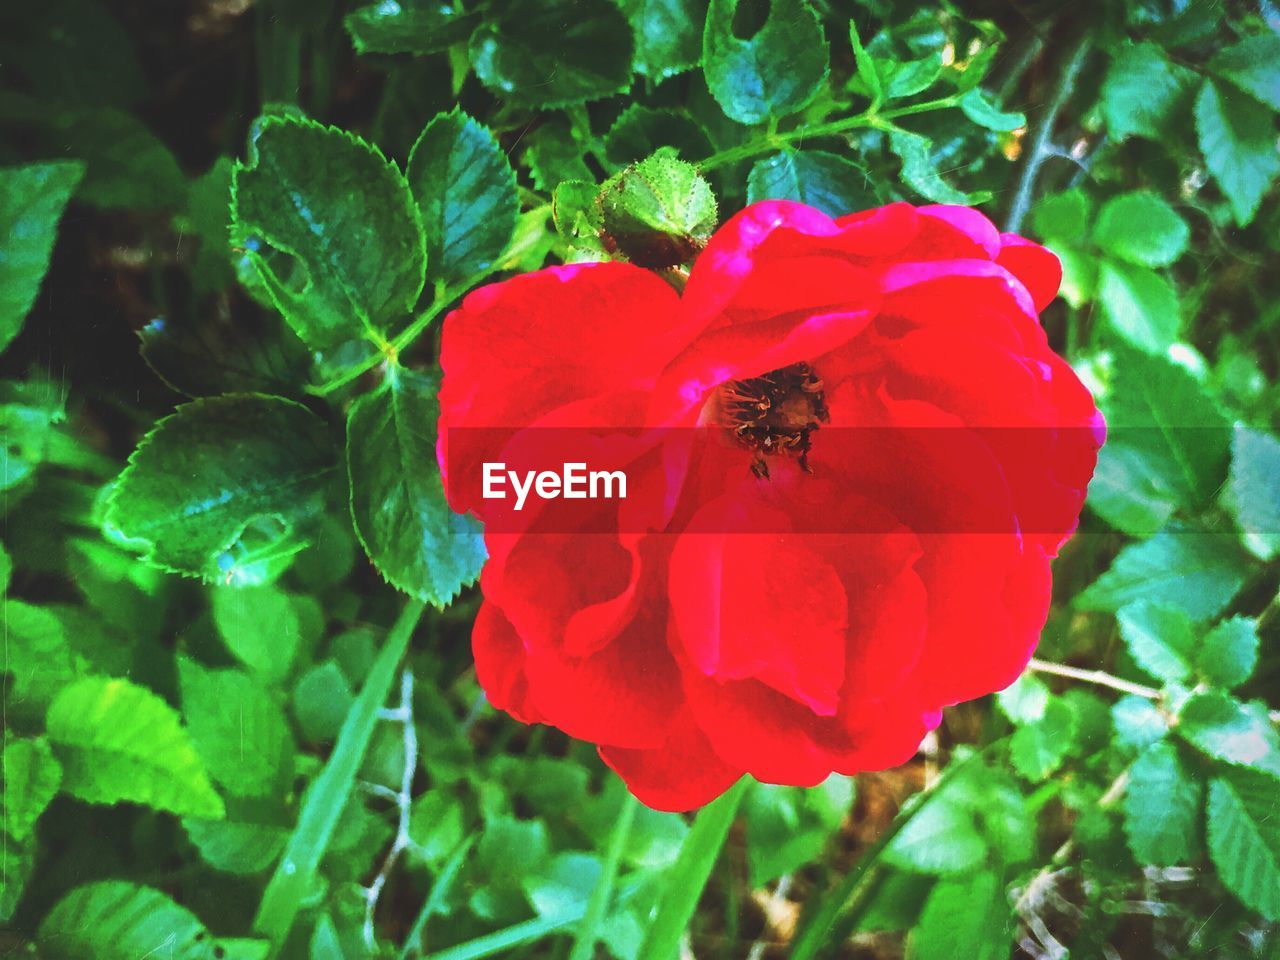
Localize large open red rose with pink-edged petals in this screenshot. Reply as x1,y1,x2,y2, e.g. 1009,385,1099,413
440,202,1103,810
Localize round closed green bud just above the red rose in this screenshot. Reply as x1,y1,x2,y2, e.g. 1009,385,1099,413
595,151,716,269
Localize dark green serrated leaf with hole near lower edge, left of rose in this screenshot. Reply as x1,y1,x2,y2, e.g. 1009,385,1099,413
105,394,335,582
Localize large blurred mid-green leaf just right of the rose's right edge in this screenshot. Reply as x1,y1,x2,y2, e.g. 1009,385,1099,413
1103,349,1231,507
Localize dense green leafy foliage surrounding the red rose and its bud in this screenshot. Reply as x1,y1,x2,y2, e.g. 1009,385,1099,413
0,0,1280,960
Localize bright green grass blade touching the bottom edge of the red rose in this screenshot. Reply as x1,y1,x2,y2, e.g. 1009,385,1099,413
637,777,750,960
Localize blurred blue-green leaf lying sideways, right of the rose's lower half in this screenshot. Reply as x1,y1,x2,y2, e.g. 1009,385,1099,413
1075,529,1251,620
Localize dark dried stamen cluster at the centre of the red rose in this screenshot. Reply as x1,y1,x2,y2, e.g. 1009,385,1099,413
719,362,831,480
